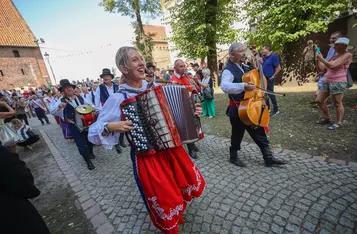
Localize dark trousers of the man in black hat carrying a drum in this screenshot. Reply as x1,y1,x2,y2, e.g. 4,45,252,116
68,123,93,157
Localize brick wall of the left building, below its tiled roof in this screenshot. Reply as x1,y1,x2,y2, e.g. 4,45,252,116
0,58,46,89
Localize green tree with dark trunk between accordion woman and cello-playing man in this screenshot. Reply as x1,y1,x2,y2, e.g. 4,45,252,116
165,0,237,86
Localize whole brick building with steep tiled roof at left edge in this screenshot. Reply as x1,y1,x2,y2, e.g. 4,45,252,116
0,0,51,89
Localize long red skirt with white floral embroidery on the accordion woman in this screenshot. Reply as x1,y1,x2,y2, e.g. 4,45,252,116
131,146,206,234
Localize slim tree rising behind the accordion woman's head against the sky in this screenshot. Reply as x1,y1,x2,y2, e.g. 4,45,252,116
99,0,161,61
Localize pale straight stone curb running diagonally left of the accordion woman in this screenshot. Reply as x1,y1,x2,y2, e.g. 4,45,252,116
39,129,114,234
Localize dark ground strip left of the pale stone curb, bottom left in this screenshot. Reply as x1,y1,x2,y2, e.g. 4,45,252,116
17,121,95,234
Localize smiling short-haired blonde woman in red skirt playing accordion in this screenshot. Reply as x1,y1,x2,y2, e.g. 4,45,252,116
88,47,206,233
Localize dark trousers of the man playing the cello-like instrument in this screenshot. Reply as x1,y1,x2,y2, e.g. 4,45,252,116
229,117,269,150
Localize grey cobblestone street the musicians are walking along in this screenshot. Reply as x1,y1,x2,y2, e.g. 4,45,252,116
34,115,357,234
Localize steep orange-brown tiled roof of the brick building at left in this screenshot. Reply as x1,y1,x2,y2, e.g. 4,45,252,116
0,0,38,46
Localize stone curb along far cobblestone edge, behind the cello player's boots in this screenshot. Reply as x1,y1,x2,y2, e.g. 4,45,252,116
205,135,357,170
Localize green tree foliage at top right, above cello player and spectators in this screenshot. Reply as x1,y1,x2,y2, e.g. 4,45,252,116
240,0,351,49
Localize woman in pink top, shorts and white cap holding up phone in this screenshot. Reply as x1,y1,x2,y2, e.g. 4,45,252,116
316,37,352,130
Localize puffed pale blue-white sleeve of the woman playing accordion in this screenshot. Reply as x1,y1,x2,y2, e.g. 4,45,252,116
88,93,124,149
